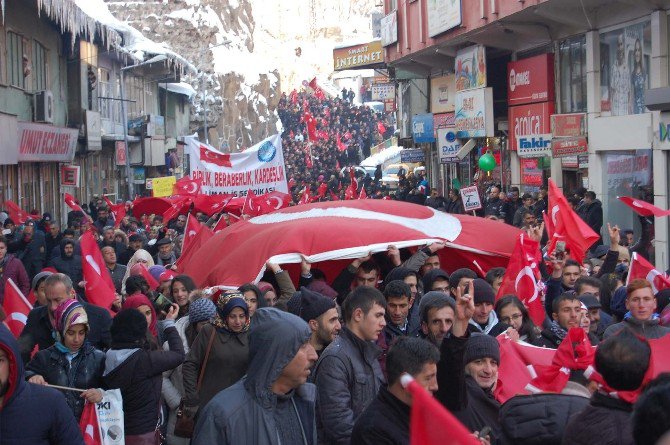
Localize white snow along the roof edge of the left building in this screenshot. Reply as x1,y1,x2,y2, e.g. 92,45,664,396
76,0,198,73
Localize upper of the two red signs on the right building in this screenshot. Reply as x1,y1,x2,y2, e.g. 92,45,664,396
507,54,554,106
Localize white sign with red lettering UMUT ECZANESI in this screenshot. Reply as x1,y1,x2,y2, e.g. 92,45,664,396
17,122,79,162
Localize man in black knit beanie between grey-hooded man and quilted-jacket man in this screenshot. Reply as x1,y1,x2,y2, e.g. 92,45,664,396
287,287,342,356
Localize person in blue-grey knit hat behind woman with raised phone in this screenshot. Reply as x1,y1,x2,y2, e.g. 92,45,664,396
162,297,216,445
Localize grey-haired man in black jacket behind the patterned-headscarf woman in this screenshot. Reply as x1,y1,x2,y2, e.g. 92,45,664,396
18,273,112,363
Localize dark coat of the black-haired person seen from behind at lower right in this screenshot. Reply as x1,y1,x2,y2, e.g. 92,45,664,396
561,392,634,445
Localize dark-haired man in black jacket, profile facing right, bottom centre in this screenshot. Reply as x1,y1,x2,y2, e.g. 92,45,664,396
351,337,440,445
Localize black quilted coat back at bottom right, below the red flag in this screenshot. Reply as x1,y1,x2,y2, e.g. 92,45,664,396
500,393,589,445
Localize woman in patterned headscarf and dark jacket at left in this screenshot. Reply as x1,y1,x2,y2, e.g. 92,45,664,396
26,300,105,420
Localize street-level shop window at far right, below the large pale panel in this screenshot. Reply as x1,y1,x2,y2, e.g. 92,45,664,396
601,150,654,258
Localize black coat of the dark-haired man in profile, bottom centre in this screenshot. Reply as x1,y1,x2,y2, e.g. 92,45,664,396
351,387,410,445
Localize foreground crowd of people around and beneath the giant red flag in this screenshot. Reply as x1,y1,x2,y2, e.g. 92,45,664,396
0,188,670,445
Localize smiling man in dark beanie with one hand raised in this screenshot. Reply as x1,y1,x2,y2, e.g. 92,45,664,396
436,284,500,443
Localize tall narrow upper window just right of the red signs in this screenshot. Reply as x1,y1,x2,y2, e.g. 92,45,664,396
559,36,586,113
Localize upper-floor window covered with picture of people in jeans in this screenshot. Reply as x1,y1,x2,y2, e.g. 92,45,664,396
600,21,651,116
